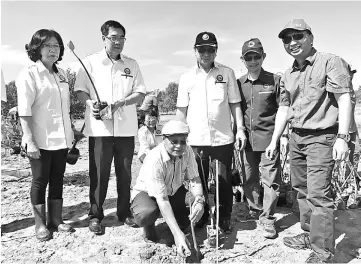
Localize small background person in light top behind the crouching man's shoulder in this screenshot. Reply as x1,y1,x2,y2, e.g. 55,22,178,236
138,106,158,163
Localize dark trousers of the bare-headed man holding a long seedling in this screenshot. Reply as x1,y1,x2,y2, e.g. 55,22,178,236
89,137,134,221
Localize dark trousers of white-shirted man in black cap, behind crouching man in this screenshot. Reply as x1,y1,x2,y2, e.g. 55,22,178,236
192,144,233,220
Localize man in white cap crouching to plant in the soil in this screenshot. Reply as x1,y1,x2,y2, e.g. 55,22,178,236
131,120,204,256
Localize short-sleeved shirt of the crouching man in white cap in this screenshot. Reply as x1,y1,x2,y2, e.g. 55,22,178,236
131,142,199,200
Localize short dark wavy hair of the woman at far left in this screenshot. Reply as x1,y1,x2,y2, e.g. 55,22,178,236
25,29,64,63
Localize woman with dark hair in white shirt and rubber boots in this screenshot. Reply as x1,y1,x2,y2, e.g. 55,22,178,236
16,29,80,241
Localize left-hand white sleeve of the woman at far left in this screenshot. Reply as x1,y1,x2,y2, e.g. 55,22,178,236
15,68,36,116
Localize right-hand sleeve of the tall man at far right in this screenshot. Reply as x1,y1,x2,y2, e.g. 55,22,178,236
326,56,352,93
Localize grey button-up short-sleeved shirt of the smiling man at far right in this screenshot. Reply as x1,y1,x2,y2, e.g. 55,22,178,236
280,48,352,130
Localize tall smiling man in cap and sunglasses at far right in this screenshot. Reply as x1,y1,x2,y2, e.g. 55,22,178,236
266,19,352,263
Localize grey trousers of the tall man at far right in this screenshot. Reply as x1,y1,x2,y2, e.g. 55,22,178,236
289,128,337,259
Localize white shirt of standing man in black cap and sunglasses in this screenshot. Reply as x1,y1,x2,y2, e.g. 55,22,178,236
177,62,241,146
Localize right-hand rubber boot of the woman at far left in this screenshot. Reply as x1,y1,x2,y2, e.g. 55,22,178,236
48,199,75,233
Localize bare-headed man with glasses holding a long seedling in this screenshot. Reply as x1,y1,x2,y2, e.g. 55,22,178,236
74,20,145,234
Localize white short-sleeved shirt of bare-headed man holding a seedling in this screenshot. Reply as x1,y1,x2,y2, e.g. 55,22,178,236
74,49,146,137
